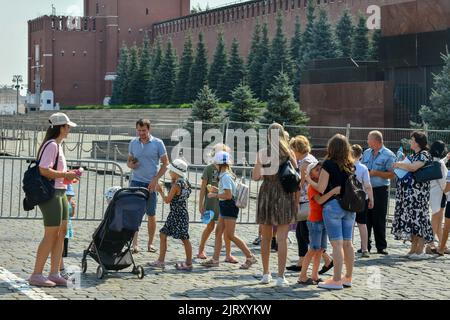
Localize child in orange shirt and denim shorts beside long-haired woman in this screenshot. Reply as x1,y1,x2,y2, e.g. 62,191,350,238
297,162,341,285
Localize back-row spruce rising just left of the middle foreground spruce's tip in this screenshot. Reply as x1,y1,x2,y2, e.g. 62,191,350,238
218,39,245,101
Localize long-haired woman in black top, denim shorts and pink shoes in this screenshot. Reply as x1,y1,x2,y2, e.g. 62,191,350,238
310,134,356,290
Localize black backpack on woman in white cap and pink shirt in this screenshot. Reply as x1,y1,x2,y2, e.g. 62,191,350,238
22,141,59,211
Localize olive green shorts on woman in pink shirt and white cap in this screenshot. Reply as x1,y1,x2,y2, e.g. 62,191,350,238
39,189,69,227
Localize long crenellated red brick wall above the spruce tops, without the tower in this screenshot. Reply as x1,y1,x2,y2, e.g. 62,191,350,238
153,0,411,59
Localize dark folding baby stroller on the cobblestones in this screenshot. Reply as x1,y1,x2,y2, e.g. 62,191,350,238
81,188,149,279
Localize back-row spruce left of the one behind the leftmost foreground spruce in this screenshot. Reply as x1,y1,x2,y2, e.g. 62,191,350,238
173,35,194,103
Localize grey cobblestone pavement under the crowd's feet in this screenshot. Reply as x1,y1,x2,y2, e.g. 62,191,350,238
0,219,450,300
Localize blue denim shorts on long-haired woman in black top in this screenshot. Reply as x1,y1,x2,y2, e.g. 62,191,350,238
323,199,356,241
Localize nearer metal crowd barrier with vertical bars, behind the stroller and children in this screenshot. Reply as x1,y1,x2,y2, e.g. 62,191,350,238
0,157,260,224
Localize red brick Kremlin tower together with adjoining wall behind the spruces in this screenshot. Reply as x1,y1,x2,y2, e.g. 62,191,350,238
28,0,408,105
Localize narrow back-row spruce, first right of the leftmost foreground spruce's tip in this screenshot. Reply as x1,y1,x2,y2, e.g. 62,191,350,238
208,31,227,97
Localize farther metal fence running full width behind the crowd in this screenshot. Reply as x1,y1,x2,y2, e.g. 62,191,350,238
0,117,450,162
